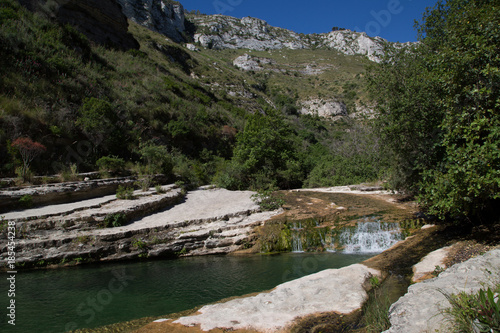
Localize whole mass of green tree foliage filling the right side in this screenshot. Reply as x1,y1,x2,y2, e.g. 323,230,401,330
372,0,500,221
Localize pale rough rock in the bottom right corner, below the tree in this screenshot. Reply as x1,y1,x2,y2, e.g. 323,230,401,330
384,249,500,333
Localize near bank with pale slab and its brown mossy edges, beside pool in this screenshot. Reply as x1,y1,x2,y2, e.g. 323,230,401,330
129,223,446,333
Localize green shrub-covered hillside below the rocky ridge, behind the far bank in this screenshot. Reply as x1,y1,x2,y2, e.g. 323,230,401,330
0,0,382,189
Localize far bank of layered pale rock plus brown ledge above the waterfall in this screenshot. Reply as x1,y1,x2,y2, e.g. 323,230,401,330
0,178,413,270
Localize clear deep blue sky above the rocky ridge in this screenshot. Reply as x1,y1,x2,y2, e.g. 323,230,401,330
180,0,437,42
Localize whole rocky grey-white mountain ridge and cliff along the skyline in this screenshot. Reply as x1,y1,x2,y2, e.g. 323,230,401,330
114,0,409,62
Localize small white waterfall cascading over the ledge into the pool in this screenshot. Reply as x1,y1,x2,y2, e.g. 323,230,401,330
338,222,403,253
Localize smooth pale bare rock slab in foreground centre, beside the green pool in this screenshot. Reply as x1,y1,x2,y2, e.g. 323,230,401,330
174,264,381,332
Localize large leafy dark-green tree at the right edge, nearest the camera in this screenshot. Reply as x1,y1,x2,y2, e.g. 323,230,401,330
419,0,500,222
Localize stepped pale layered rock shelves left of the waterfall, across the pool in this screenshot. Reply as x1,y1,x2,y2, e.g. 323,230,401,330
0,186,281,266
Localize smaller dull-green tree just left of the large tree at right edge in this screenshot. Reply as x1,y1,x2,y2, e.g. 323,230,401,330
369,44,443,195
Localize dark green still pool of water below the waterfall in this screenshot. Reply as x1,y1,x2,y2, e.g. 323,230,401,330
0,253,373,333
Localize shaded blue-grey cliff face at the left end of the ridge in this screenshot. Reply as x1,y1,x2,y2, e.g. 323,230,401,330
118,0,186,42
